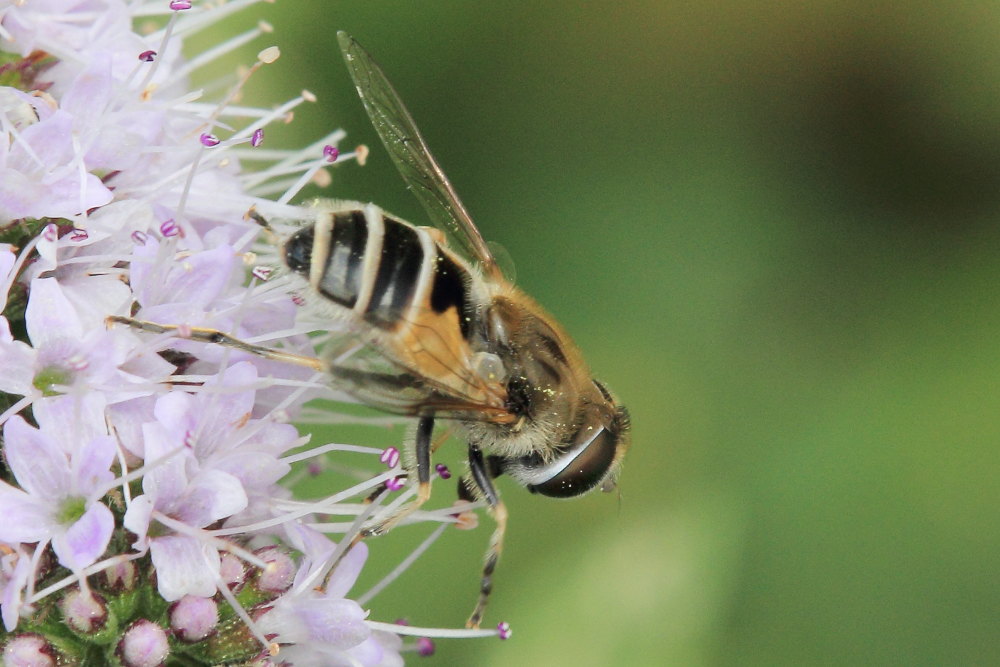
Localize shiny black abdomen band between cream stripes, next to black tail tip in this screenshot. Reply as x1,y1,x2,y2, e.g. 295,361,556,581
317,211,368,308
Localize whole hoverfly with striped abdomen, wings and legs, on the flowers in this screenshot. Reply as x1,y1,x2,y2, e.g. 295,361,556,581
111,32,629,627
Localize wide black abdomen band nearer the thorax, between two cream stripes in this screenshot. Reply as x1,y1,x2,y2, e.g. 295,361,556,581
364,217,424,328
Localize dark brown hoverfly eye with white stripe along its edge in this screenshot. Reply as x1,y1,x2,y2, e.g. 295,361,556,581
527,426,618,498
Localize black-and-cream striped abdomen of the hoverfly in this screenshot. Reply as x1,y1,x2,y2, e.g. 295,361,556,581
284,206,472,338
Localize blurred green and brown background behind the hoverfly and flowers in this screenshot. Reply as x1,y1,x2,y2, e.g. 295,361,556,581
203,0,1000,665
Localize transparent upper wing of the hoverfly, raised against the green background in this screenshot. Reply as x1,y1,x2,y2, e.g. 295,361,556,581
337,32,503,279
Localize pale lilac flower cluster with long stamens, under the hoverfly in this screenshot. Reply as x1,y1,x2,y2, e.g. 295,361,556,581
0,0,497,666
